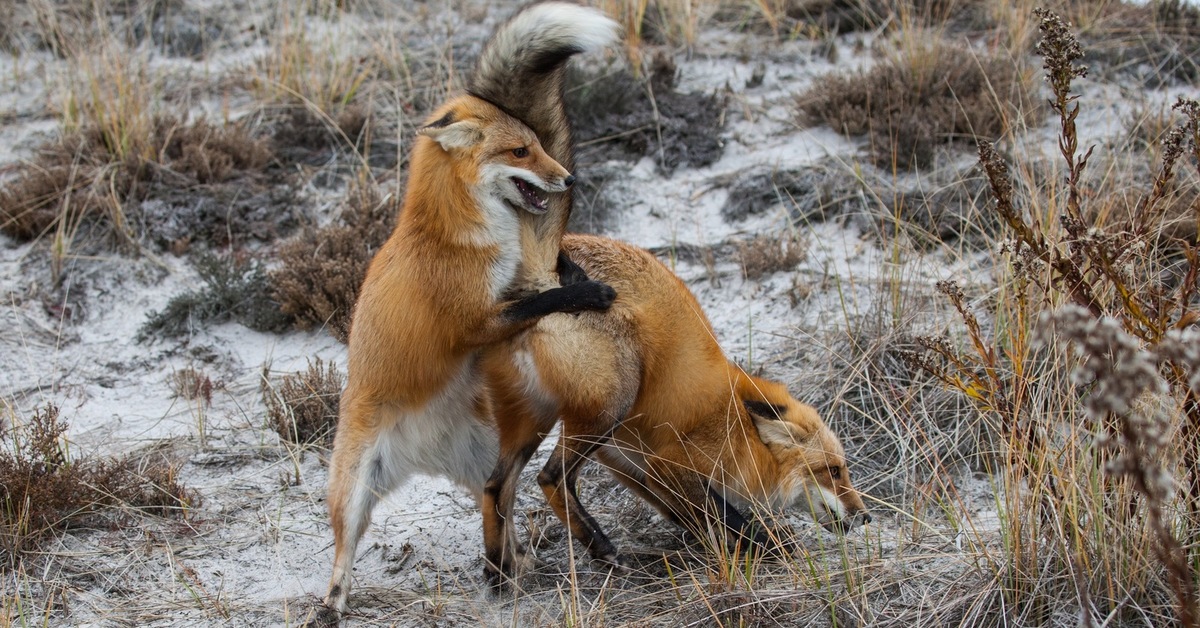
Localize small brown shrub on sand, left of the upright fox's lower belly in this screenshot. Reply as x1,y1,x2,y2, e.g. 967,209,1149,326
259,358,346,447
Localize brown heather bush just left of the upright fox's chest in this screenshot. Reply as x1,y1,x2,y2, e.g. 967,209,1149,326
270,176,398,342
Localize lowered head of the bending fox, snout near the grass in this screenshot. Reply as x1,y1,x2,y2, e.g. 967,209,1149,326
743,384,871,532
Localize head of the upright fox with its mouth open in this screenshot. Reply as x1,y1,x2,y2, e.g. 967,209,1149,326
418,96,575,214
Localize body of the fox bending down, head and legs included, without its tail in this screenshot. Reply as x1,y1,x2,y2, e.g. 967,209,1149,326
484,235,870,586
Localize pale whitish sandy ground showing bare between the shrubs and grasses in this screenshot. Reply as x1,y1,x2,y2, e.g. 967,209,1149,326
0,2,1190,626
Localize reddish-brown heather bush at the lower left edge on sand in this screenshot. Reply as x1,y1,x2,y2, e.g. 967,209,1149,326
0,405,199,567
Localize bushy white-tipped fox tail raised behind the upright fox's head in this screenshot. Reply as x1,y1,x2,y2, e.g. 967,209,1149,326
467,2,620,244
